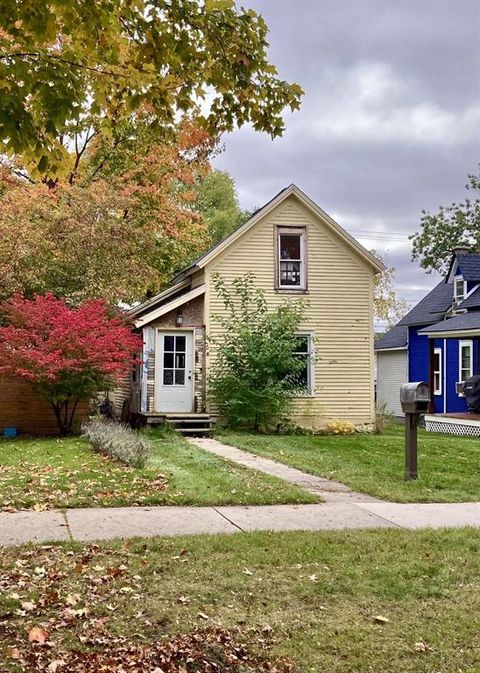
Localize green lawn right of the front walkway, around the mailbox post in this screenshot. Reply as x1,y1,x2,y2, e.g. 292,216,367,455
218,425,480,502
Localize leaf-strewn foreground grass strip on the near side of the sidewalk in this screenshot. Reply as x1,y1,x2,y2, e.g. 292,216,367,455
0,529,480,673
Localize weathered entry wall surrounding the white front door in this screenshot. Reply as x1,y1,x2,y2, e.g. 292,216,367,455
147,296,206,413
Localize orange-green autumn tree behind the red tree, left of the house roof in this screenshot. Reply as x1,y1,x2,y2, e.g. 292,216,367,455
0,120,214,304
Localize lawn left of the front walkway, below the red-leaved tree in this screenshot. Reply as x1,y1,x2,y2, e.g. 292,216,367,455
0,433,318,510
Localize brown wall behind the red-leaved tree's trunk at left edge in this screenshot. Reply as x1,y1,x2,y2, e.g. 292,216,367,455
0,378,89,436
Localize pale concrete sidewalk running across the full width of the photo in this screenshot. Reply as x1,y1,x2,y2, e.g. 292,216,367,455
0,502,480,546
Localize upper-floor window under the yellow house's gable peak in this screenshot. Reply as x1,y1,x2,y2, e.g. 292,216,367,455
277,227,306,290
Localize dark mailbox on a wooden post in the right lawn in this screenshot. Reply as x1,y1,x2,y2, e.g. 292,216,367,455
400,381,430,481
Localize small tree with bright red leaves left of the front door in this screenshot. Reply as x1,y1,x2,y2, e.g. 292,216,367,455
0,294,142,434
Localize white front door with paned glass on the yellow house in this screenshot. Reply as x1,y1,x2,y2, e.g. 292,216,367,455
155,330,193,412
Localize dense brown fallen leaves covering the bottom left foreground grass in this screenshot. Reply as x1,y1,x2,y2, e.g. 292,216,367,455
0,544,292,673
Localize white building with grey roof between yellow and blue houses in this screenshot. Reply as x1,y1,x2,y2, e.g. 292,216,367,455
375,325,408,416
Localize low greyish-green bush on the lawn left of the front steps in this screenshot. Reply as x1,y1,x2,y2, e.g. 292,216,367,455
82,420,151,468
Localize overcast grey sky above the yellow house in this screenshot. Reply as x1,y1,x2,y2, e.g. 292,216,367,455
215,0,480,302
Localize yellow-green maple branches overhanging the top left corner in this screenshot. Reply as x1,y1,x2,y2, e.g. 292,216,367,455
0,0,303,176
